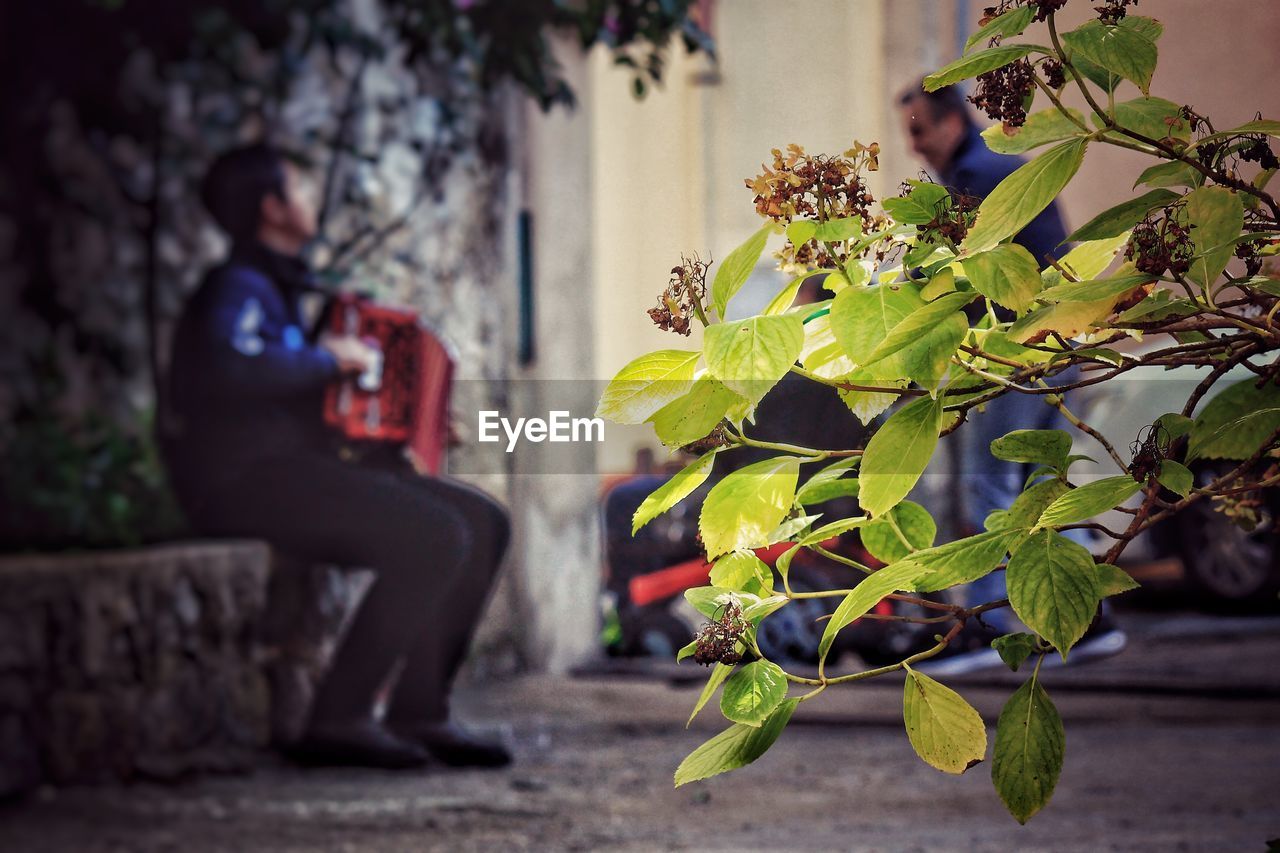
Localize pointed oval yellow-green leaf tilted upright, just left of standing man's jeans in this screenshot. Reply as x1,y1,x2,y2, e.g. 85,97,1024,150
858,397,942,516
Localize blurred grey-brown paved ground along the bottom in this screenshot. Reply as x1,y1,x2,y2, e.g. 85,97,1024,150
0,594,1280,853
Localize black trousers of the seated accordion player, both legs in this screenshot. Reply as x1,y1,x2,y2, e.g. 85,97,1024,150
178,452,511,725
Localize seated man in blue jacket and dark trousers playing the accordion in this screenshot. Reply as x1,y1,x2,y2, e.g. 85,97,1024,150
164,145,511,767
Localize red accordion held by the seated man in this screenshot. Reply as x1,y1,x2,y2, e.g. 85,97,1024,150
324,295,453,474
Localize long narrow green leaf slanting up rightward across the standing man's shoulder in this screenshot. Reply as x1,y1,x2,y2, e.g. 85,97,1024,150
964,140,1088,255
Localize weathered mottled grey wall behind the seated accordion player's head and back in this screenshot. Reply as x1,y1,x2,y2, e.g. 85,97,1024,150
0,0,598,674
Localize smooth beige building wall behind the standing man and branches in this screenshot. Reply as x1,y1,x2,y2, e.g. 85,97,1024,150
586,0,1280,471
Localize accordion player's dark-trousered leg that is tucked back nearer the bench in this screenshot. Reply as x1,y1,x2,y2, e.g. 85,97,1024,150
186,455,472,763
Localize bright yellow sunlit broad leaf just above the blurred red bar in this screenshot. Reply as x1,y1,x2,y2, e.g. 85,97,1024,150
698,456,800,560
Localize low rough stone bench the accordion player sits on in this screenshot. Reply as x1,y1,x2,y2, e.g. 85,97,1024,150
0,542,362,797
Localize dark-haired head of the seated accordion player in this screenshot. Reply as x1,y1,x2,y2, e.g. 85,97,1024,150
201,143,316,255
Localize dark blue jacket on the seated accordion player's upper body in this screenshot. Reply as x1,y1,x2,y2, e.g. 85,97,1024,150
164,239,338,491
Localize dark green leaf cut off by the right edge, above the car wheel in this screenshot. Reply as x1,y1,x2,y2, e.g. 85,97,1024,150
1187,379,1280,462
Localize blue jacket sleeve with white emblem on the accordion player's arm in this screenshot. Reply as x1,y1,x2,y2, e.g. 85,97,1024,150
195,270,338,397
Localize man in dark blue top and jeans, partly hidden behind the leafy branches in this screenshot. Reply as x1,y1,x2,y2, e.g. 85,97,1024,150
899,81,1125,672
